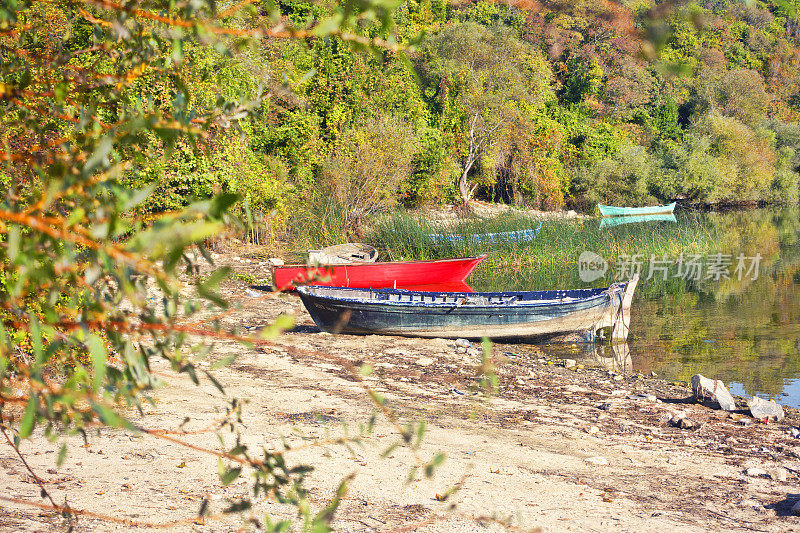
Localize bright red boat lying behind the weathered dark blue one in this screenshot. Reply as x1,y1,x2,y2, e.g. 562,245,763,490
274,254,486,291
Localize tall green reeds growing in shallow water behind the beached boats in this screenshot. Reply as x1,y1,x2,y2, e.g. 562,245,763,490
367,213,719,290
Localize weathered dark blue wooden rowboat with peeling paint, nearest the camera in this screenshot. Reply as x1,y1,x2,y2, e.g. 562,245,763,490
297,277,638,340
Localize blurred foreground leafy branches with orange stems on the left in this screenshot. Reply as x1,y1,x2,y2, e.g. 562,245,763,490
0,0,450,532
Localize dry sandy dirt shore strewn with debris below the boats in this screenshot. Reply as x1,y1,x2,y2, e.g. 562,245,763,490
0,251,800,532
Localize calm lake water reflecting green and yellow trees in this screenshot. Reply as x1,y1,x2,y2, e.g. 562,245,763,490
470,209,800,407
